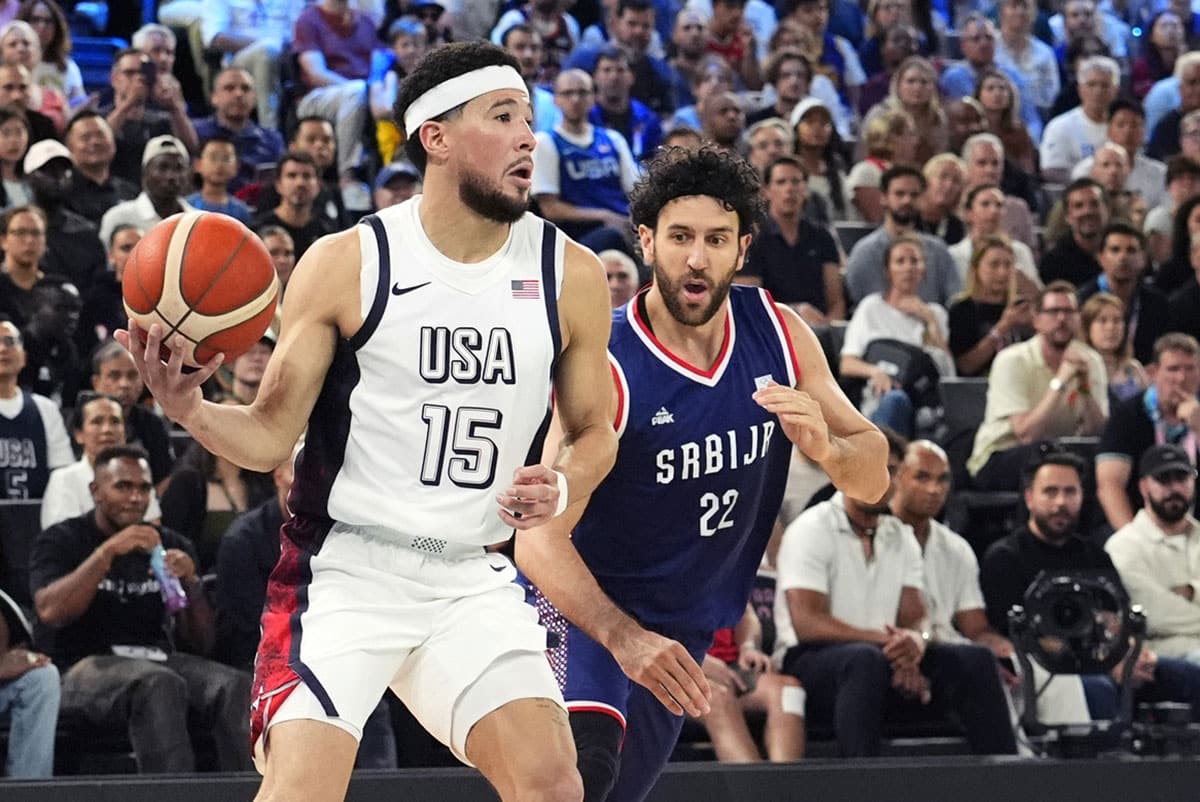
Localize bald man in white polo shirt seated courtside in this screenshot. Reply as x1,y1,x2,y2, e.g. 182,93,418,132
892,441,1091,724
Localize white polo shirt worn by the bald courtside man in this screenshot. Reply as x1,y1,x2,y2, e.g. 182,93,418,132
923,521,984,644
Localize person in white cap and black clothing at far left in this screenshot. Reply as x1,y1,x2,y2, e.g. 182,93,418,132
24,139,108,293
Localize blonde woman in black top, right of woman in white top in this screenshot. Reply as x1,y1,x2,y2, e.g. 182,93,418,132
950,234,1036,376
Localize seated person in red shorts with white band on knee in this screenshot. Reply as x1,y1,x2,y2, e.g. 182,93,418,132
700,604,804,764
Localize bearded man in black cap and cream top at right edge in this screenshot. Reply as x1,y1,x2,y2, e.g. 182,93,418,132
1104,443,1200,663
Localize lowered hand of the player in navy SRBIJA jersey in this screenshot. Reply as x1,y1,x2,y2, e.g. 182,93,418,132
612,628,713,718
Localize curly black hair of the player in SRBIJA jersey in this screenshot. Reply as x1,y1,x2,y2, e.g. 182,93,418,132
629,145,766,237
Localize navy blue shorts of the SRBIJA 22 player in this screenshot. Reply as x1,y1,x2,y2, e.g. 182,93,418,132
529,587,713,802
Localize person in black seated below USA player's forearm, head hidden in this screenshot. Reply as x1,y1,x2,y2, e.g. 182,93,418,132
162,401,275,574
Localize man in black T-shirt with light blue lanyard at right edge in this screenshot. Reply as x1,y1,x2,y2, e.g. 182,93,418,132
1096,331,1200,529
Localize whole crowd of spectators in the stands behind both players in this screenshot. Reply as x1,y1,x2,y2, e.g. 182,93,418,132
0,0,1200,777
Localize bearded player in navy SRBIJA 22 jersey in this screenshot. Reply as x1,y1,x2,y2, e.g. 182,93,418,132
517,148,889,802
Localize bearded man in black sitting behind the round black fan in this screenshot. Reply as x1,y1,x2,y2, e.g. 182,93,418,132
979,448,1200,720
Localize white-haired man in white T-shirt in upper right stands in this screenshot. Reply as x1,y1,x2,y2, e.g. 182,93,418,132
1039,55,1121,181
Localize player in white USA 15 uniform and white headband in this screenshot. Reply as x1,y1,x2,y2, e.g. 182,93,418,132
121,42,707,802
